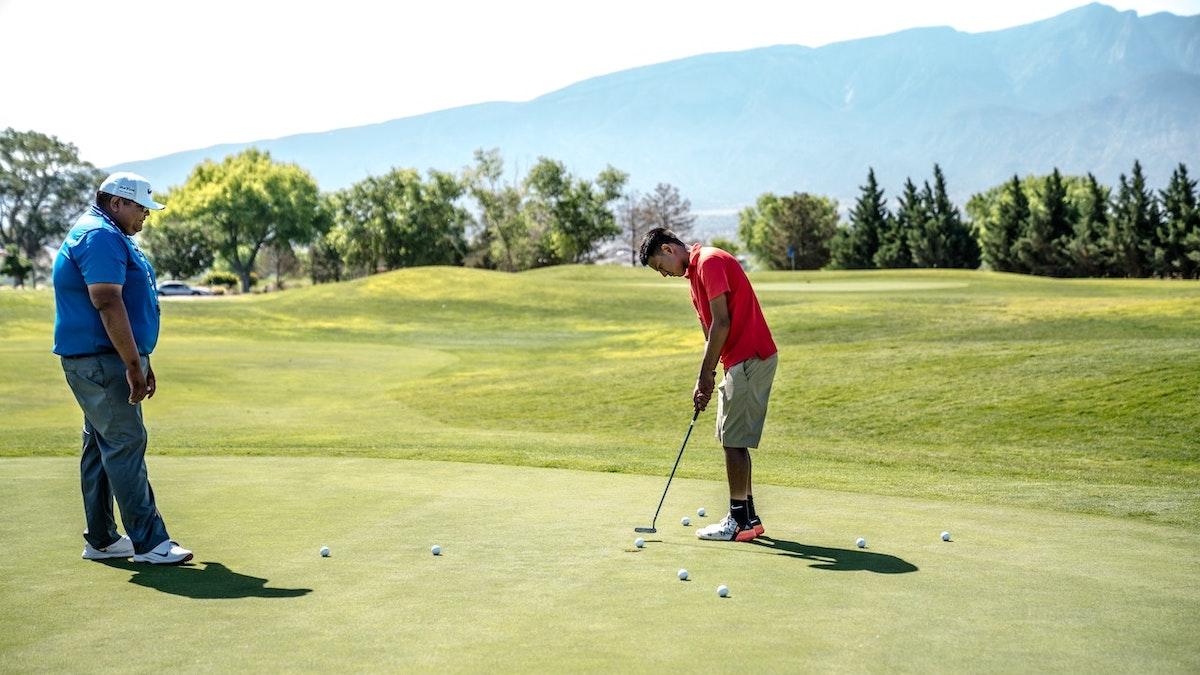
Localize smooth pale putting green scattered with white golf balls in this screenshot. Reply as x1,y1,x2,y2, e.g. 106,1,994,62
0,449,1200,673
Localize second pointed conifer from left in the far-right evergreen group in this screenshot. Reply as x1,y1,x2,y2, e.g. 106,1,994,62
1013,168,1075,276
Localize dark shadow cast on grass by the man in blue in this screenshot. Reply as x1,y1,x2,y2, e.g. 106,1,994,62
100,558,312,599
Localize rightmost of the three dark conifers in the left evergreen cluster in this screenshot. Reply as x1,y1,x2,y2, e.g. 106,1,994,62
908,163,979,268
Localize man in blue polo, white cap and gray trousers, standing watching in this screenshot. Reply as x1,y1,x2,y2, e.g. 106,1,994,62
54,173,192,565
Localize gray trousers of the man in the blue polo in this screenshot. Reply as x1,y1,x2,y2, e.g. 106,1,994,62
62,354,170,554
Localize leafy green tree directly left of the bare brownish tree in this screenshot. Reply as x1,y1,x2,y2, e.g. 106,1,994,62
524,157,629,267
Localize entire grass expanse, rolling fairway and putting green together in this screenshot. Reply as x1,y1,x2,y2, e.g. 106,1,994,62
0,268,1200,671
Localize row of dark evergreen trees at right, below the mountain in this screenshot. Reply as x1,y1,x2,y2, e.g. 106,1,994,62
832,162,1200,279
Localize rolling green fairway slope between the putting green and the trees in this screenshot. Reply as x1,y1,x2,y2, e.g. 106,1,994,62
0,267,1200,527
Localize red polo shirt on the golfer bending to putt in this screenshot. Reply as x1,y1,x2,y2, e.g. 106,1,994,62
684,244,779,370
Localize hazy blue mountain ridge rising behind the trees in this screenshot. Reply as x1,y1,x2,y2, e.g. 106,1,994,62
114,5,1200,208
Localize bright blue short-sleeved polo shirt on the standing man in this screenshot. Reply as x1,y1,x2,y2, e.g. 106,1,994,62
54,205,158,357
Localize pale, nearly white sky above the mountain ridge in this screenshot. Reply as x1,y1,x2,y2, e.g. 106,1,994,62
0,0,1200,166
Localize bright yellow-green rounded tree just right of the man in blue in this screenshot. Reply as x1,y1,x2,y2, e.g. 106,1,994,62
170,148,320,293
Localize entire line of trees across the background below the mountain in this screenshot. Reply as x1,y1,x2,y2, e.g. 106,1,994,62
0,129,1200,284
